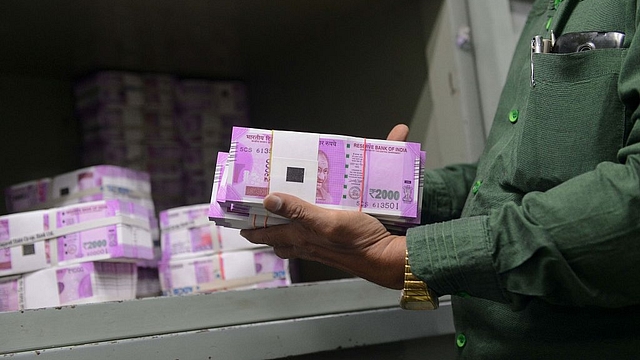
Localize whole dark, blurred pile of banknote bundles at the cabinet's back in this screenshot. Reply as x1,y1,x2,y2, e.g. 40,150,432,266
74,71,249,211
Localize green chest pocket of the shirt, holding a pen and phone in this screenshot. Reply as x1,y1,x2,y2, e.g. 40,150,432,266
514,49,626,191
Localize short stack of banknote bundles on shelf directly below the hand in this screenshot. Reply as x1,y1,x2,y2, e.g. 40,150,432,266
158,204,291,296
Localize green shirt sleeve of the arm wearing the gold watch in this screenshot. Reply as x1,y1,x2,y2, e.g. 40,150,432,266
407,7,640,308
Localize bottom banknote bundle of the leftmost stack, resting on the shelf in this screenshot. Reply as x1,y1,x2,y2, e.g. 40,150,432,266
0,262,137,311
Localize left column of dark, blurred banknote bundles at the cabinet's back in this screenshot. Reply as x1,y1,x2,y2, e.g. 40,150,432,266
74,71,183,212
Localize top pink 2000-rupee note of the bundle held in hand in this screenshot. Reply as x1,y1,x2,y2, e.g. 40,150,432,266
225,127,420,217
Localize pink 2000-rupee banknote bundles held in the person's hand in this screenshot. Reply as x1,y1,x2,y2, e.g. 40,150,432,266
209,127,426,231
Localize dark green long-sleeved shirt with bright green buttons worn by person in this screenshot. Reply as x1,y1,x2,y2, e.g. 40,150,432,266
407,0,640,360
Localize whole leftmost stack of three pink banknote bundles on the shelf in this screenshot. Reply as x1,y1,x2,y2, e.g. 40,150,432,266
0,166,159,311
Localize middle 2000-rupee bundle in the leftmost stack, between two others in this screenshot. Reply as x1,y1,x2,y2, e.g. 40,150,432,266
0,200,154,276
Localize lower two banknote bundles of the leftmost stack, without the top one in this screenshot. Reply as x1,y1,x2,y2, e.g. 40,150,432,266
0,199,154,311
